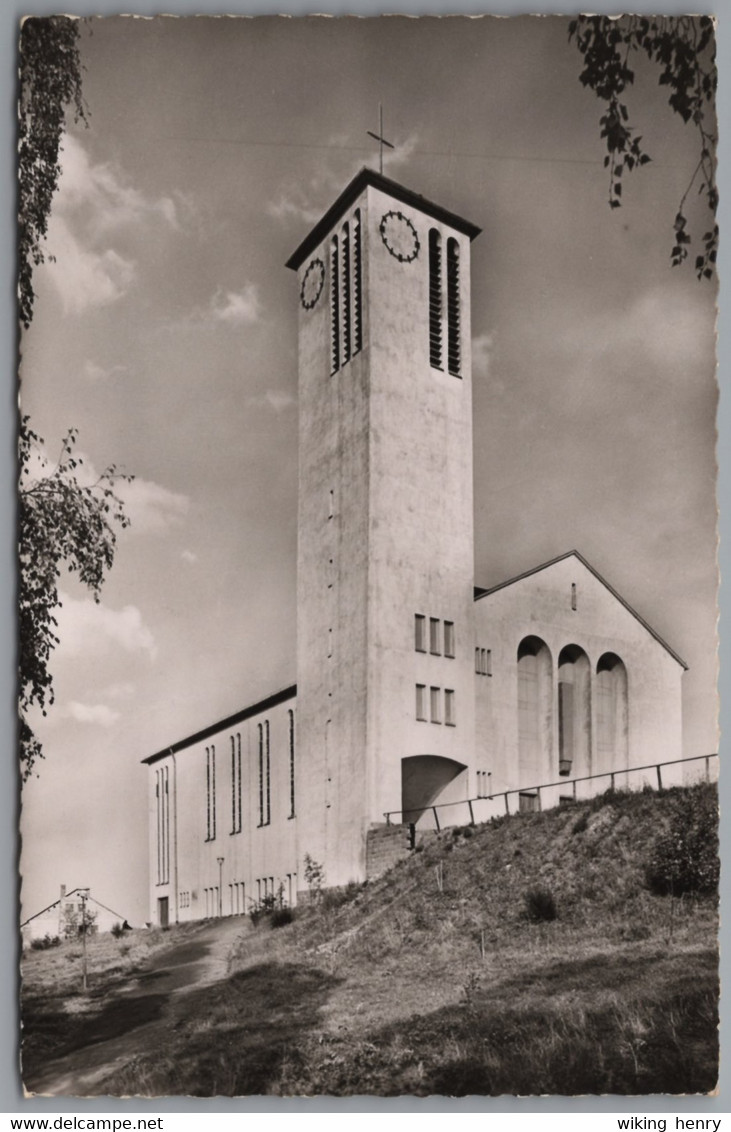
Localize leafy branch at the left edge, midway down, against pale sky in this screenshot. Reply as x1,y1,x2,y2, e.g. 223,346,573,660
18,417,131,781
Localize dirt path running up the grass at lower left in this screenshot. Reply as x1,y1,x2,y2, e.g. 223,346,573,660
25,918,244,1097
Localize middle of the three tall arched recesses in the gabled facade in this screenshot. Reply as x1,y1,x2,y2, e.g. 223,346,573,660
558,644,592,777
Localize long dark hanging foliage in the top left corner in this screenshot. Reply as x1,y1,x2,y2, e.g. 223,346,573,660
18,16,86,328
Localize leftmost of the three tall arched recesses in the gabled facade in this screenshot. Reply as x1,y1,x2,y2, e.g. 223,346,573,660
517,636,552,786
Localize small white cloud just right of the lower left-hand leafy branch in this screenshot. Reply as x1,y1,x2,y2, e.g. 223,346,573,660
58,593,157,660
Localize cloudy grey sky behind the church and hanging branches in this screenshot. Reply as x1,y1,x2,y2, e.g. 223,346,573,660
20,17,717,924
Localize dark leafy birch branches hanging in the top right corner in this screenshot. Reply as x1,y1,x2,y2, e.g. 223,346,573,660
568,16,719,278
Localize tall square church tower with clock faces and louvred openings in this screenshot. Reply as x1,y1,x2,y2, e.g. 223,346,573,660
287,169,480,886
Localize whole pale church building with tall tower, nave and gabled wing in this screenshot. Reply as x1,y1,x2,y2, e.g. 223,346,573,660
144,169,686,926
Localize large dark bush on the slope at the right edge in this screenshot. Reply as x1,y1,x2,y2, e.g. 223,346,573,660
645,788,720,897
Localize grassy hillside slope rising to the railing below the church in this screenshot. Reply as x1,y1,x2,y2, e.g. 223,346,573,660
75,787,717,1095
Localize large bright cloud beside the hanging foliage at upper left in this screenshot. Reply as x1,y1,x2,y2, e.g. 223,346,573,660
45,135,179,315
